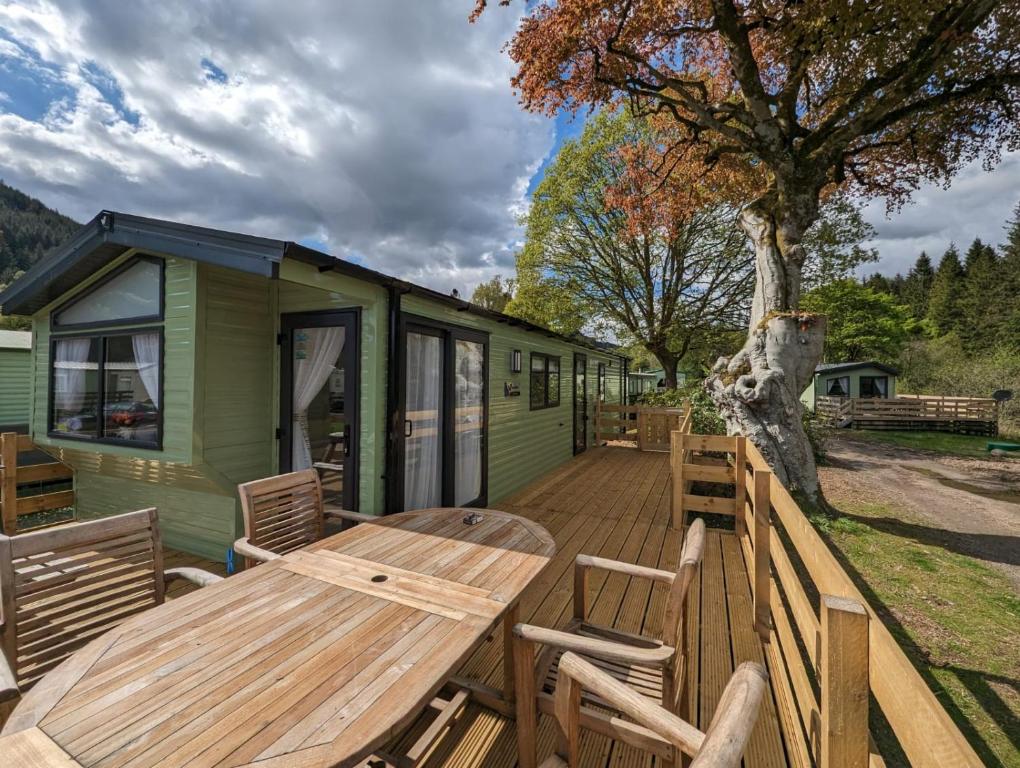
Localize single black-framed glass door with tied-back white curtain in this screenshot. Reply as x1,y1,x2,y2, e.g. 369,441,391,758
278,310,359,510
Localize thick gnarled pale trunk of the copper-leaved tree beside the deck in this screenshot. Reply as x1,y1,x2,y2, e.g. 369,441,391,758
706,197,825,501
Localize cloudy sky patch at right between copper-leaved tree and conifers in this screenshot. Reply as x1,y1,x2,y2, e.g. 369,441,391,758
862,152,1020,274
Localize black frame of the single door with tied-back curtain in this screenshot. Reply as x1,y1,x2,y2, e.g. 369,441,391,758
276,307,361,511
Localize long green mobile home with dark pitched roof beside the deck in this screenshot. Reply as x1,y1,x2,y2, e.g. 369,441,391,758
0,211,626,559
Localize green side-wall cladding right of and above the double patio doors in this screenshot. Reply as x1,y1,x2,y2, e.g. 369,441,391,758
401,296,621,506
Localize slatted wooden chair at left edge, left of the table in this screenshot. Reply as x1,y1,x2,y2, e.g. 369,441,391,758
0,509,221,701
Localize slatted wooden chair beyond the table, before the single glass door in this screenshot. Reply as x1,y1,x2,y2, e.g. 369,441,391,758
234,469,374,567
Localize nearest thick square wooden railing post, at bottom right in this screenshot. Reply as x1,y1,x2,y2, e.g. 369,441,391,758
819,595,870,768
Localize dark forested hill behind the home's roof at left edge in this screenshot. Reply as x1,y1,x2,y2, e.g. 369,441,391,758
0,182,81,284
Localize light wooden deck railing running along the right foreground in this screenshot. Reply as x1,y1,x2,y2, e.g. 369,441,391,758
670,431,981,768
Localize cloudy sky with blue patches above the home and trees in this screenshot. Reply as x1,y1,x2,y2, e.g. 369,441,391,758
0,0,1020,292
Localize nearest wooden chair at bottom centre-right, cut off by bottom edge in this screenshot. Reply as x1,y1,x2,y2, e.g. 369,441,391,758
542,653,768,768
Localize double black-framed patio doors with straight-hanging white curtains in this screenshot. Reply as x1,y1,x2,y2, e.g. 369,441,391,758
394,320,489,511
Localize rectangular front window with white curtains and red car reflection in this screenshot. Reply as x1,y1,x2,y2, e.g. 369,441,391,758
49,328,163,448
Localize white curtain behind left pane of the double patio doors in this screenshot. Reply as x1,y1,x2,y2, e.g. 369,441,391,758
404,332,443,510
